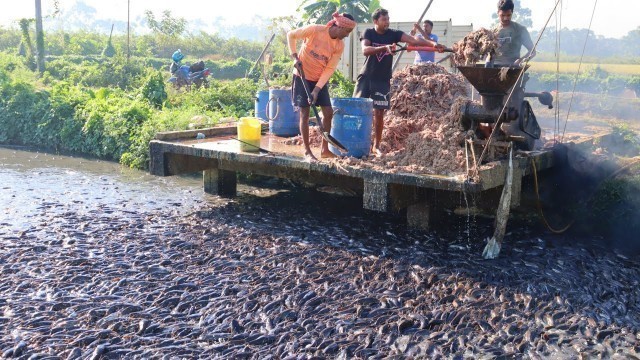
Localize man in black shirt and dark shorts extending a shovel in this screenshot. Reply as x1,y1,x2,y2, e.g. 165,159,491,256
353,9,444,155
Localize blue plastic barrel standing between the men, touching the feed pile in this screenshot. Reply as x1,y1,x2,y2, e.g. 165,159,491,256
329,98,373,158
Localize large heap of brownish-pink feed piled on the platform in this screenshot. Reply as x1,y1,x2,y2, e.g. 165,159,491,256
335,63,468,175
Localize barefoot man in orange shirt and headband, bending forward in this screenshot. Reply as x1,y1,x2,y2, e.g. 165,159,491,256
287,12,356,161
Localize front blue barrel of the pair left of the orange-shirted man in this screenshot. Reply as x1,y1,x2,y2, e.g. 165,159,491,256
267,89,300,136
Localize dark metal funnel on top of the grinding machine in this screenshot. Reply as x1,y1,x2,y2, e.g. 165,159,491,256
458,65,528,95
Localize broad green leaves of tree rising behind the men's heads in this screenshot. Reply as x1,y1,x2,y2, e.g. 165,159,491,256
297,0,380,24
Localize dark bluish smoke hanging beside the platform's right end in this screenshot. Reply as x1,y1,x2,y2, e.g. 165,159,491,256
540,141,640,255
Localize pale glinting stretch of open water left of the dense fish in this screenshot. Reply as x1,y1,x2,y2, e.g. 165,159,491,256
0,147,255,230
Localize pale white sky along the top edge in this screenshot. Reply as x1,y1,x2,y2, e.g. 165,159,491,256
0,0,640,38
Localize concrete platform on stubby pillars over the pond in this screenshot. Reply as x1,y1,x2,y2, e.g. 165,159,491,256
150,125,553,228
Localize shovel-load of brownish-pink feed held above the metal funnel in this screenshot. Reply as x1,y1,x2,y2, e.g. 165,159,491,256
451,28,500,66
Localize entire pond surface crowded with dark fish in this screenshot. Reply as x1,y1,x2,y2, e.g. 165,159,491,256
0,149,640,359
